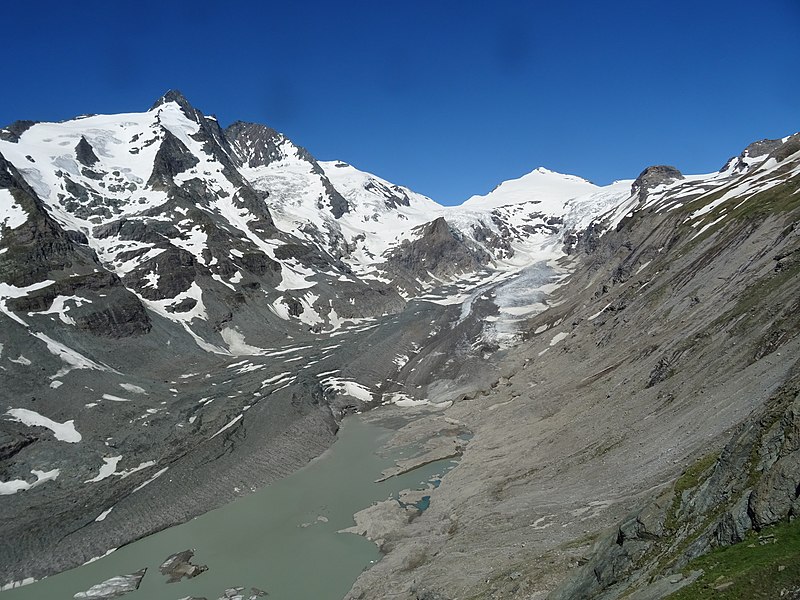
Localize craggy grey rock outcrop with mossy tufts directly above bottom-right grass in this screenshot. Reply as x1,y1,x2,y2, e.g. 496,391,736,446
548,370,800,600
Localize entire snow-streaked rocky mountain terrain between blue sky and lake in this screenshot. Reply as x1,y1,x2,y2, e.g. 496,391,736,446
0,91,800,600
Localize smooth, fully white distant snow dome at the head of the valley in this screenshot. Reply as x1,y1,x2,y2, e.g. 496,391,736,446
463,167,598,212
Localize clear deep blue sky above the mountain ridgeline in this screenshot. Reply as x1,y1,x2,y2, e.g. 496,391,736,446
0,0,800,204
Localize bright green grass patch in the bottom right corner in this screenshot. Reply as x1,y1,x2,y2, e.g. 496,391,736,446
668,519,800,600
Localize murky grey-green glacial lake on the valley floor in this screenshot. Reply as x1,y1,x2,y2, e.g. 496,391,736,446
0,416,453,600
